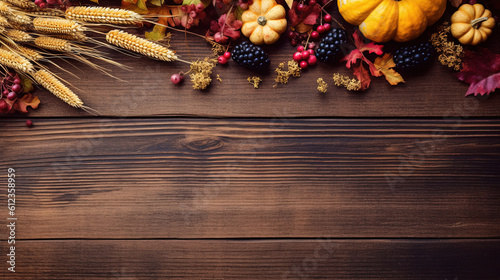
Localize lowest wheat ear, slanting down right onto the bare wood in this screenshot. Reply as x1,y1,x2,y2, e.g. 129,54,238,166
32,70,83,108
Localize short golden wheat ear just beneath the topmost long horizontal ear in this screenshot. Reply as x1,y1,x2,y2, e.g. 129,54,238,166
33,17,85,34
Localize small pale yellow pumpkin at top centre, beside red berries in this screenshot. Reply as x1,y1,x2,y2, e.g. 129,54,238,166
241,0,286,45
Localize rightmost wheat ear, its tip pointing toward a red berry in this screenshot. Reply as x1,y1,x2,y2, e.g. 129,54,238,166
106,29,179,63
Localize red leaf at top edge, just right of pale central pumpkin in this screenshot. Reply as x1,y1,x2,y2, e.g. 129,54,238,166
288,1,321,33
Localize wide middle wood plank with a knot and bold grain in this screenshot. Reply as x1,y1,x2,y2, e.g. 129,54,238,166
0,118,500,239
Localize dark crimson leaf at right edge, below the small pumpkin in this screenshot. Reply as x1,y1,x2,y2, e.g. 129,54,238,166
456,48,500,96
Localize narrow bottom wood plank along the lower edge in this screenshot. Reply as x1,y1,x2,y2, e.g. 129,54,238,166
0,239,500,280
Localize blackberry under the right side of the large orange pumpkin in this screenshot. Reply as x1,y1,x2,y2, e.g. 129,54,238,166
394,43,434,73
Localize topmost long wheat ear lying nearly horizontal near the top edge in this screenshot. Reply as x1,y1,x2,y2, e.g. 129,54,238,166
65,6,143,25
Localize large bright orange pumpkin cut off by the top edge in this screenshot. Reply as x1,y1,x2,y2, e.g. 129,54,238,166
337,0,447,43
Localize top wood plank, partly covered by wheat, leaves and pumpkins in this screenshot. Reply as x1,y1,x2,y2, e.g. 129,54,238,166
21,5,500,117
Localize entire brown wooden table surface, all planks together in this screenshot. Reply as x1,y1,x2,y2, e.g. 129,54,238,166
0,1,500,280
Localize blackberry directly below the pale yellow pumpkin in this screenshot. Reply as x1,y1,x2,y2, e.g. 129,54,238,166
231,41,271,71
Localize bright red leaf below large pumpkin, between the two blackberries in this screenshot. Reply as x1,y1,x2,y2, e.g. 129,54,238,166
342,30,384,90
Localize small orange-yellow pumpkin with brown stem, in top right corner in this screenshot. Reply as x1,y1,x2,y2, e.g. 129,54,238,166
451,4,495,46
